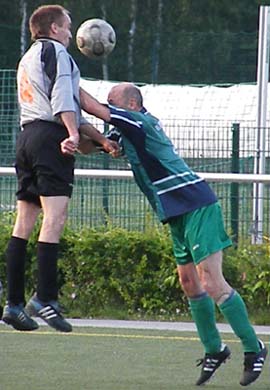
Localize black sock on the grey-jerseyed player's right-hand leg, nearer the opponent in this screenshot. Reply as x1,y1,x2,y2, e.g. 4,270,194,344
37,241,59,302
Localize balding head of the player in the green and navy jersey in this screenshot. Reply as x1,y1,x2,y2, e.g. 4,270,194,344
108,83,143,111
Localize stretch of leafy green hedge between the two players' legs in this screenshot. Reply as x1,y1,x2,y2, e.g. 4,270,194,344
58,227,186,316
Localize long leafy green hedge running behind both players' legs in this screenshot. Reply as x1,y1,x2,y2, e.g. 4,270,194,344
0,214,270,323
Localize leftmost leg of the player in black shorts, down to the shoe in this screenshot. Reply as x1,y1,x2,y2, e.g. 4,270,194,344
3,123,43,330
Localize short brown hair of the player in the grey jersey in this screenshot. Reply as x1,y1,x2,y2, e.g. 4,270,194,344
29,5,69,41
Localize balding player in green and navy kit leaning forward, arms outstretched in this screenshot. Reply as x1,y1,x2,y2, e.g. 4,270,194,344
76,83,267,386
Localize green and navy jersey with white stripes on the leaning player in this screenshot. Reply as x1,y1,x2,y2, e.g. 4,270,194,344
108,105,217,222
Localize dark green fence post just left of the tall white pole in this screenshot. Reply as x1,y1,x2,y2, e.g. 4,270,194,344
231,123,240,245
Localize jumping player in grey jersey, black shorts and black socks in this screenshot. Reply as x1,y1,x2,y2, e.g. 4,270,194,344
3,5,117,332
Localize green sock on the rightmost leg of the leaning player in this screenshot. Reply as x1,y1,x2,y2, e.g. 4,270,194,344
219,291,260,353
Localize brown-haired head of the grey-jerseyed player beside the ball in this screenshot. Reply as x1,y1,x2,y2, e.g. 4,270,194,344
29,5,72,47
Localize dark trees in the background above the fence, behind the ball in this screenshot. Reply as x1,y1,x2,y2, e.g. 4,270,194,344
0,0,261,84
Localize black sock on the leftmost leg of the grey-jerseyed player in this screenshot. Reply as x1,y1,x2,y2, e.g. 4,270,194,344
6,236,27,305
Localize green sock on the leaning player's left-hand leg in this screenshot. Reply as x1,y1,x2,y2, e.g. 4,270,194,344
189,293,221,354
